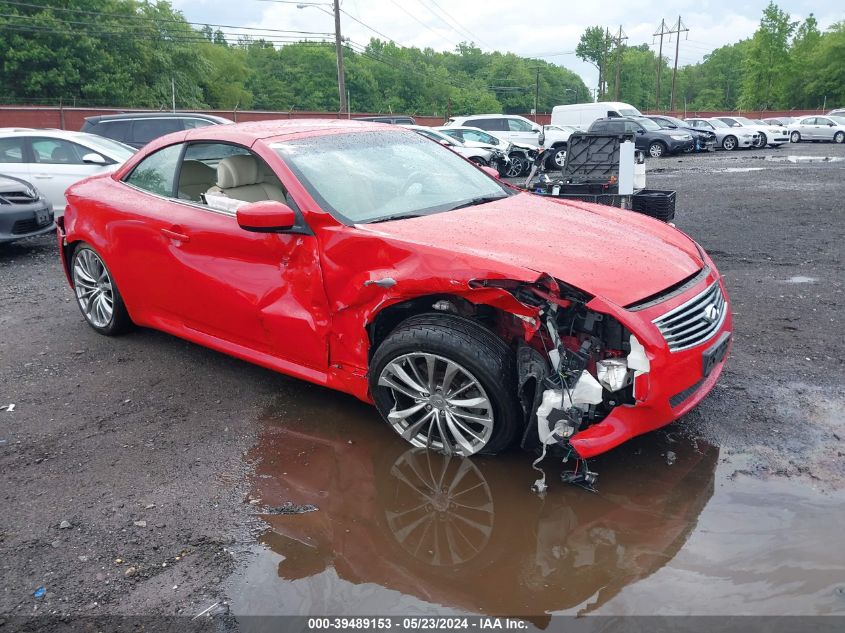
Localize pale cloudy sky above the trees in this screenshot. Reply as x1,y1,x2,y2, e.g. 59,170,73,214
173,0,845,93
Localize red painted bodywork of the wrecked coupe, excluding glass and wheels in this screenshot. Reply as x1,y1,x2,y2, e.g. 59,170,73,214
59,121,731,458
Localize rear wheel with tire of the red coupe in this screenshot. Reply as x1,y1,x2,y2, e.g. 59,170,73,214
70,242,133,336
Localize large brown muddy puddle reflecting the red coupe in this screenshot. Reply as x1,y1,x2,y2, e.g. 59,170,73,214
228,384,845,628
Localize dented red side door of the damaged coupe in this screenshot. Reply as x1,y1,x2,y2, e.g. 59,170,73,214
127,142,328,370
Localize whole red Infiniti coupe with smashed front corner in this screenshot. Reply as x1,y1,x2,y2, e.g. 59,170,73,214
58,120,731,458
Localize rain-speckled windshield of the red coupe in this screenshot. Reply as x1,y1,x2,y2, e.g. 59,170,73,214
271,131,511,225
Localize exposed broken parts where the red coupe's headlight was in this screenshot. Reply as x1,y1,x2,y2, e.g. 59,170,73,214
470,275,650,492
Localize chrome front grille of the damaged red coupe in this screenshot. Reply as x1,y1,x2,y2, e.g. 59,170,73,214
653,281,727,352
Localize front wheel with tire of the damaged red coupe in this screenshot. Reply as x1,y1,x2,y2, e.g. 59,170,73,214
370,314,524,457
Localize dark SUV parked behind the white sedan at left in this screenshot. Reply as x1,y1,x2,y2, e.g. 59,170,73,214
81,112,233,147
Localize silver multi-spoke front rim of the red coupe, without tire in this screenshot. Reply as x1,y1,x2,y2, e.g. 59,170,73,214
378,352,493,456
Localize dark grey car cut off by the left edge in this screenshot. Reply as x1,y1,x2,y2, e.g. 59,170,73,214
0,175,56,243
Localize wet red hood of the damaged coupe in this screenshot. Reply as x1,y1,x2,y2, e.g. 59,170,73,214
358,193,704,306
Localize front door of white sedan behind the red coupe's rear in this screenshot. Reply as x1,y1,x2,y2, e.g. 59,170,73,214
26,136,106,215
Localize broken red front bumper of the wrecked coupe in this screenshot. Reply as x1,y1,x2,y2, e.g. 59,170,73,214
569,267,733,459
